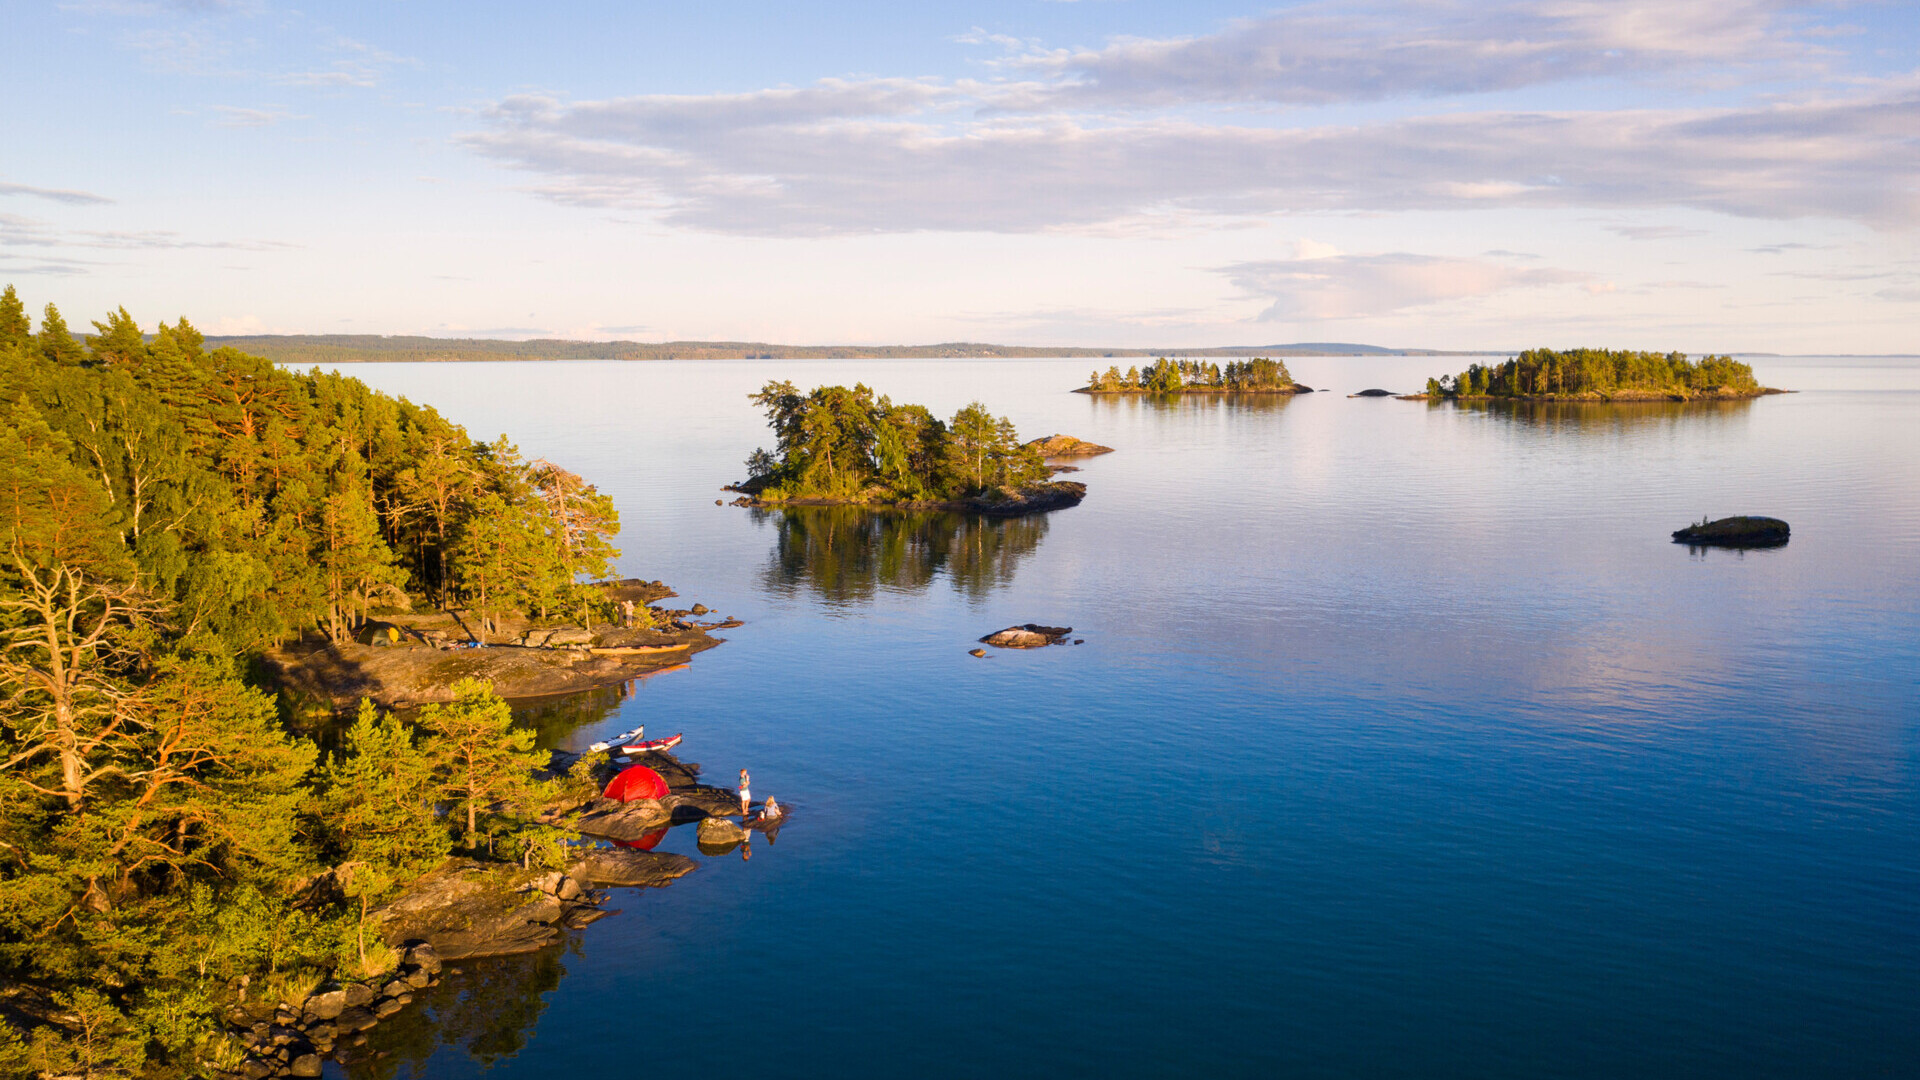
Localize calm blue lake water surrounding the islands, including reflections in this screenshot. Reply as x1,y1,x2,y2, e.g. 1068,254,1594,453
330,357,1920,1078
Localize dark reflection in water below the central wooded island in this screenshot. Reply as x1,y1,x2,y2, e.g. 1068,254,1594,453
753,505,1046,603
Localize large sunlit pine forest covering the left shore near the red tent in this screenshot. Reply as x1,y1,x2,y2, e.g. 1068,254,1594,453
0,286,618,1076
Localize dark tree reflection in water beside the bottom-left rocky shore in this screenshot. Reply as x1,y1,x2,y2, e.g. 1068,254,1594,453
346,940,578,1080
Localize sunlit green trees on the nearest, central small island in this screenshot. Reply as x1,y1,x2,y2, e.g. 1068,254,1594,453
741,382,1052,502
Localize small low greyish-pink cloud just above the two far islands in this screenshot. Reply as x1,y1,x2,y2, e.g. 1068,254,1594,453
1219,252,1582,321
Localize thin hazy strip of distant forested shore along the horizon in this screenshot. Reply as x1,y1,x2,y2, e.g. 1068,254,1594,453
207,334,1473,365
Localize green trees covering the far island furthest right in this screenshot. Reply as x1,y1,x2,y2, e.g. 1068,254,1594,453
1427,348,1763,398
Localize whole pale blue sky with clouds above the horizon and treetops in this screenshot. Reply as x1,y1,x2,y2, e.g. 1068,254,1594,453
0,0,1920,354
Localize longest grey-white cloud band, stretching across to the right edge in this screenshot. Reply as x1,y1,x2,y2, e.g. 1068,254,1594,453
461,79,1920,234
